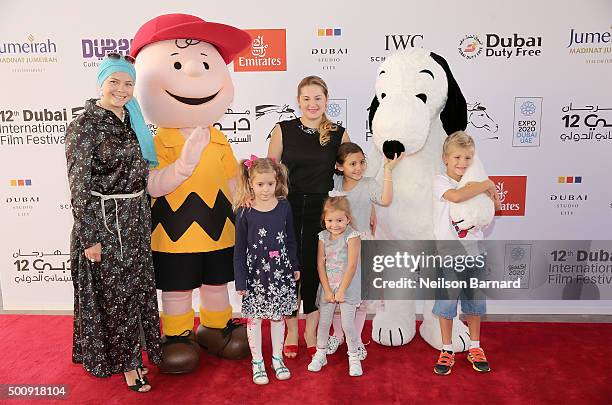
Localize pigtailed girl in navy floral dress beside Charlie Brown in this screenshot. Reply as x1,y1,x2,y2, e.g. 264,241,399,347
234,155,300,384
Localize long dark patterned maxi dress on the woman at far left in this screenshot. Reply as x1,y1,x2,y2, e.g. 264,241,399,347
66,100,161,377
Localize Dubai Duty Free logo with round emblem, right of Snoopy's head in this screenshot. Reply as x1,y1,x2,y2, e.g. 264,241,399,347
458,33,542,59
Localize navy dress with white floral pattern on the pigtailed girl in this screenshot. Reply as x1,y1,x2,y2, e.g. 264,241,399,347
234,200,299,320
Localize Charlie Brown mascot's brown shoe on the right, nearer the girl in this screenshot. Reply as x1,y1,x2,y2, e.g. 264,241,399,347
196,319,251,360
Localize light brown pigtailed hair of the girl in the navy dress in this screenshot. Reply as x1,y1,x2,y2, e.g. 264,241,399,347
232,158,289,211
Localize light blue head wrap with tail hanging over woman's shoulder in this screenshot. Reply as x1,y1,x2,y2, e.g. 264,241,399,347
98,57,159,167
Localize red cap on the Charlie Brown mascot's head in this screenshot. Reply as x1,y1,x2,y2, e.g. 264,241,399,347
130,14,251,64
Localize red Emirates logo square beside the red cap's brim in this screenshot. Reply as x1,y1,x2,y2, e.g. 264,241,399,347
234,28,287,72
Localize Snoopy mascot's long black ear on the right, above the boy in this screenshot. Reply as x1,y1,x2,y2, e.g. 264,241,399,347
429,52,467,135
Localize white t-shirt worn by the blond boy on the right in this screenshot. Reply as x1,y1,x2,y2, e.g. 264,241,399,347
433,174,484,240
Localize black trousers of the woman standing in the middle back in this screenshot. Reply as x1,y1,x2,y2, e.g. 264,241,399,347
287,193,327,315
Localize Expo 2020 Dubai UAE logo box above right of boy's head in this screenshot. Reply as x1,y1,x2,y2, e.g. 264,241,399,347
512,97,543,147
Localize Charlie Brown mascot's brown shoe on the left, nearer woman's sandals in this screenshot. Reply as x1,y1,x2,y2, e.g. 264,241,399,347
159,330,202,374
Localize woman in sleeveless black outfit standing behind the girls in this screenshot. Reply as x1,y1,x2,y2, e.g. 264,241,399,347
268,76,350,358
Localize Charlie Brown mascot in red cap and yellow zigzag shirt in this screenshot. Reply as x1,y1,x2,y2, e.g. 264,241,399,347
131,14,251,374
